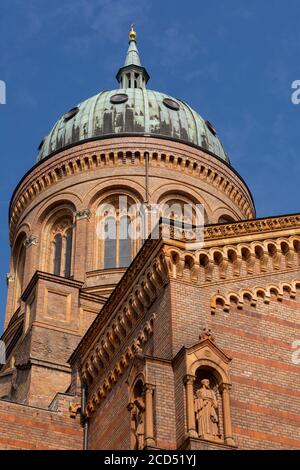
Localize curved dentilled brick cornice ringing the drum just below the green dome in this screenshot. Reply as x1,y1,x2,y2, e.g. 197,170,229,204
10,137,255,240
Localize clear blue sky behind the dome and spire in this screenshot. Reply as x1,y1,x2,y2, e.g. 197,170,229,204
0,0,300,330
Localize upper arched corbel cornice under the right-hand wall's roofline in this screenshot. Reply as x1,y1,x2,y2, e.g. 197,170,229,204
164,232,300,285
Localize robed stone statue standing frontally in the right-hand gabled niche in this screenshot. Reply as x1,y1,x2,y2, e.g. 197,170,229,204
194,379,220,439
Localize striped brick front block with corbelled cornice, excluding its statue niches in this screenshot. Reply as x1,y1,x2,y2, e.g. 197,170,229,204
71,216,300,449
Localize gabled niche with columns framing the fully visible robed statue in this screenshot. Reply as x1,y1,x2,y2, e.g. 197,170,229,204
184,329,235,446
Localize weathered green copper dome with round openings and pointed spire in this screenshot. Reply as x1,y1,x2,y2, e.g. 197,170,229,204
38,29,229,162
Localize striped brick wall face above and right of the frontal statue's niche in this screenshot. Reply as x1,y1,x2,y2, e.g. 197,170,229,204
171,272,300,449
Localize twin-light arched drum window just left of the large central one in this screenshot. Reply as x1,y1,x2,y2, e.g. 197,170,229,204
50,218,73,277
